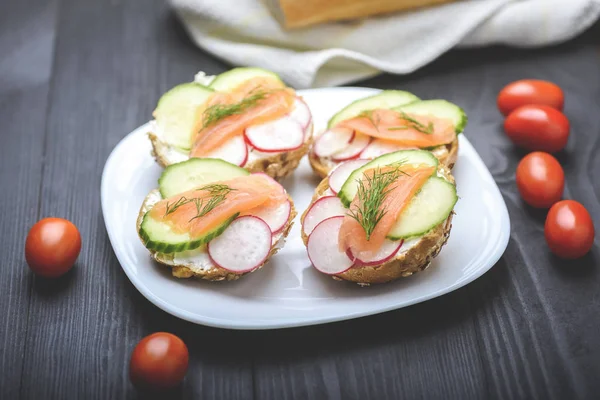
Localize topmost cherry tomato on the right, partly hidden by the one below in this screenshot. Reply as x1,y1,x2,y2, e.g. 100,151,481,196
498,79,565,115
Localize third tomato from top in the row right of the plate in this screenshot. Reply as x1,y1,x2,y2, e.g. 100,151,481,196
517,151,565,208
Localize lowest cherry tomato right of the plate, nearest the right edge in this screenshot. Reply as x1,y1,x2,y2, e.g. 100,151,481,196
544,200,594,259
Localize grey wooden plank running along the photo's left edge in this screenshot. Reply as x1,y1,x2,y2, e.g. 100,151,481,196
0,0,56,399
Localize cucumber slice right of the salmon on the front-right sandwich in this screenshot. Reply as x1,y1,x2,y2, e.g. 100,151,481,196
387,176,458,240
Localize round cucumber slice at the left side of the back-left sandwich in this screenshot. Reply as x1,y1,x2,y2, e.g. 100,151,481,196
153,82,213,150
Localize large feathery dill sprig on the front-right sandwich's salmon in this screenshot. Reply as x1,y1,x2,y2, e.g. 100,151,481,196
348,161,406,240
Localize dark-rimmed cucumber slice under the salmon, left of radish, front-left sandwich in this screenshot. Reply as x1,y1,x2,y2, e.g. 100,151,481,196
140,212,238,253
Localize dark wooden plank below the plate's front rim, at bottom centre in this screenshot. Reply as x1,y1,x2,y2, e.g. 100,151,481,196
255,290,485,399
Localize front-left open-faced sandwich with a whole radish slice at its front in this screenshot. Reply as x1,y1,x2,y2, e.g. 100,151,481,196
137,158,296,281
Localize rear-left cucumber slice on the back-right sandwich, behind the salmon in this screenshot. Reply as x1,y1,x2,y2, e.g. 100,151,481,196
327,90,419,128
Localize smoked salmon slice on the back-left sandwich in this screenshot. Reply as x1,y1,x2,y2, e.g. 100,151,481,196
190,78,296,157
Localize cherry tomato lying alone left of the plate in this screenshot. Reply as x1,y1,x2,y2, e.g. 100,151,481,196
25,218,81,278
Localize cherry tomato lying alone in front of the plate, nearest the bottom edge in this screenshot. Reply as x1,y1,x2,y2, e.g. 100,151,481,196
129,332,189,389
